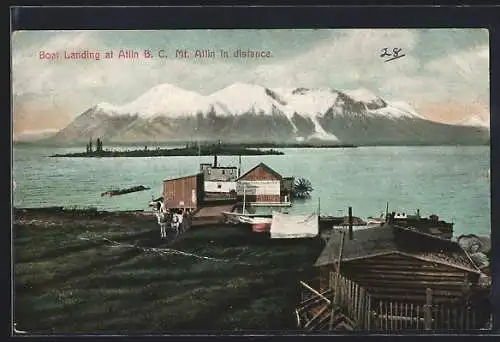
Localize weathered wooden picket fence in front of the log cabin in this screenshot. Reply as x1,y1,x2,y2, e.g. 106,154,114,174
324,272,489,331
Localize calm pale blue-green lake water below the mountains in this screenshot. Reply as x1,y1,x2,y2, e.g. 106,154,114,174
13,146,491,235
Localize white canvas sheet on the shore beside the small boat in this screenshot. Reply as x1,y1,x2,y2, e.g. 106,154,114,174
271,212,319,239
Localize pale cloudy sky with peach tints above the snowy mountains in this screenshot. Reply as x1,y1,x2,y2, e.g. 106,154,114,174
12,29,489,134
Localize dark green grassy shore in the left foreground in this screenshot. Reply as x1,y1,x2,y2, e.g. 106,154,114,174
14,211,323,333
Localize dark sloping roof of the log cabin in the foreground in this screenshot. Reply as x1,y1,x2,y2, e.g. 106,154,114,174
314,225,480,272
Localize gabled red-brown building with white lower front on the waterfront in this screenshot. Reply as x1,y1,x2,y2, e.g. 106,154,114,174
236,163,283,204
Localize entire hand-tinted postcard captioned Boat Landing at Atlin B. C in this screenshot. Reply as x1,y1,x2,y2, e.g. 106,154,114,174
12,28,492,335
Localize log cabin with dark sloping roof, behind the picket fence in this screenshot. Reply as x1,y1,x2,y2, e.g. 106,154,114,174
315,224,482,302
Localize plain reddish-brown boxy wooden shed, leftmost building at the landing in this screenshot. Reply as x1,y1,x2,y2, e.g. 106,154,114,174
163,173,205,210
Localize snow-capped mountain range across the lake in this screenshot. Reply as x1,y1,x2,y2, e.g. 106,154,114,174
48,83,489,144
